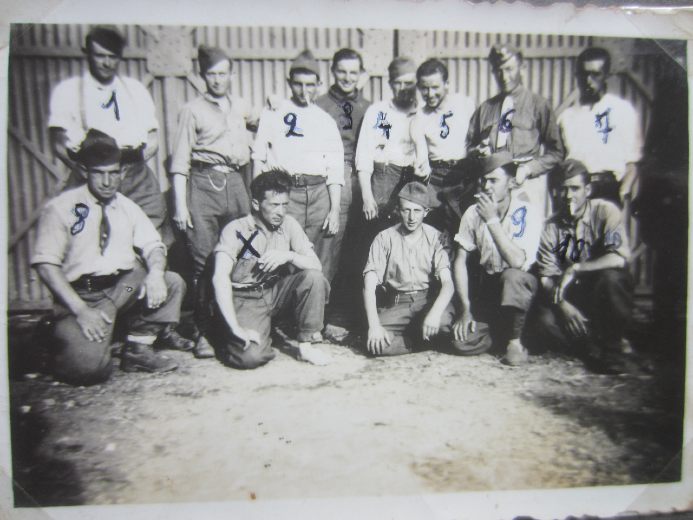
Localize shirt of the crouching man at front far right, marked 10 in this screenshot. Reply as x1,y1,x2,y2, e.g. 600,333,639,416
537,199,630,276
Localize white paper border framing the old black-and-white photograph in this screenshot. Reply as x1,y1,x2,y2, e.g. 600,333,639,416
0,0,693,519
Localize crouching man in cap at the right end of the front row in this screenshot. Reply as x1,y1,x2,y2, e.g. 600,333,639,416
536,159,633,374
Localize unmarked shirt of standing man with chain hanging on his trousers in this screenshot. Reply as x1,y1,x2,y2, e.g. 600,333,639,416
171,94,253,175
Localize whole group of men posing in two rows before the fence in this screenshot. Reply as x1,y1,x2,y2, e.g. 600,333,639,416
32,26,641,384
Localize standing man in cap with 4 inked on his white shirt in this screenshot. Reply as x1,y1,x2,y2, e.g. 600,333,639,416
356,56,417,238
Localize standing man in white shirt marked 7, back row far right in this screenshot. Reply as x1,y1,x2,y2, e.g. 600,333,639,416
558,47,642,204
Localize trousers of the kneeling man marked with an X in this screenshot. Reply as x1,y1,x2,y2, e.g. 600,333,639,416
215,269,329,369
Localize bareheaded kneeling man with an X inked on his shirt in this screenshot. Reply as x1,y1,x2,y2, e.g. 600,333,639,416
212,170,331,368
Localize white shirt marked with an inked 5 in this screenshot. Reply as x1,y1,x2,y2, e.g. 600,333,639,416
412,94,474,161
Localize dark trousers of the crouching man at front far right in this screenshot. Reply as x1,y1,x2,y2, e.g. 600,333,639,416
532,269,633,355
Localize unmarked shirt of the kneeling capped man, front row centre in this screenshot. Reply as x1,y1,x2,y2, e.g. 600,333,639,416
363,224,450,292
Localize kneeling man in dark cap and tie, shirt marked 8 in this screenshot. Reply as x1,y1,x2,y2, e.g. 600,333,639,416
31,130,192,385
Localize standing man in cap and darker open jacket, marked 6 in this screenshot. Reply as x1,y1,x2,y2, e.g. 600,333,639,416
467,44,563,215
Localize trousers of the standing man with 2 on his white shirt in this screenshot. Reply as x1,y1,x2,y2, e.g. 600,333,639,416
287,176,338,280
